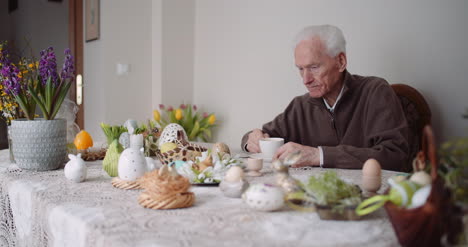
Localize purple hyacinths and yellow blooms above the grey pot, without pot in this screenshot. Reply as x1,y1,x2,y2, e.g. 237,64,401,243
0,44,74,120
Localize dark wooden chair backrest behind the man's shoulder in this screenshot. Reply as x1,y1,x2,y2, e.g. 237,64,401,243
391,84,431,172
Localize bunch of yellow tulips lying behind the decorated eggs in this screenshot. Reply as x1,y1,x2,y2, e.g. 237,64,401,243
153,104,216,142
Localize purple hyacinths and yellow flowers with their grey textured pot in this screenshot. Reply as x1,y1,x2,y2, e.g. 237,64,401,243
0,47,74,171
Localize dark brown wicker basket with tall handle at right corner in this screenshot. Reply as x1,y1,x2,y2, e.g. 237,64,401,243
385,126,461,246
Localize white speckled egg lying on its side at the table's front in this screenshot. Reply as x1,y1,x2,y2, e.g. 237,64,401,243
242,184,284,211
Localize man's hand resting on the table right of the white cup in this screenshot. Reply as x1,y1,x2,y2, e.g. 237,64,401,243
273,142,320,167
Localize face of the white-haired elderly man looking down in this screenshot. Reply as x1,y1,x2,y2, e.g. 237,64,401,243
294,38,346,100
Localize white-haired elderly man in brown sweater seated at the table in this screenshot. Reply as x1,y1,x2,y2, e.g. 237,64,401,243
242,25,409,170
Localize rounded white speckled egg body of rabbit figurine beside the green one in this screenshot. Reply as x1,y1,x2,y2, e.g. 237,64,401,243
118,148,148,181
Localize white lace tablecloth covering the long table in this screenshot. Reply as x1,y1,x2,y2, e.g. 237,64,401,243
0,150,398,247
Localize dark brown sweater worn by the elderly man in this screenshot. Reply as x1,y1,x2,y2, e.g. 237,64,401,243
242,72,409,170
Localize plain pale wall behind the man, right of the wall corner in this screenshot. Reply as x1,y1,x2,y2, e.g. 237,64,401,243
194,0,468,146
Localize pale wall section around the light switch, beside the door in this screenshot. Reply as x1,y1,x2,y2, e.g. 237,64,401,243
83,0,154,139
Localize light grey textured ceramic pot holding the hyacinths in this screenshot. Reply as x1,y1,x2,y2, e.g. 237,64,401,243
10,119,67,171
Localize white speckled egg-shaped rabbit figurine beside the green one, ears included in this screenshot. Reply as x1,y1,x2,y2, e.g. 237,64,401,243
118,129,148,181
